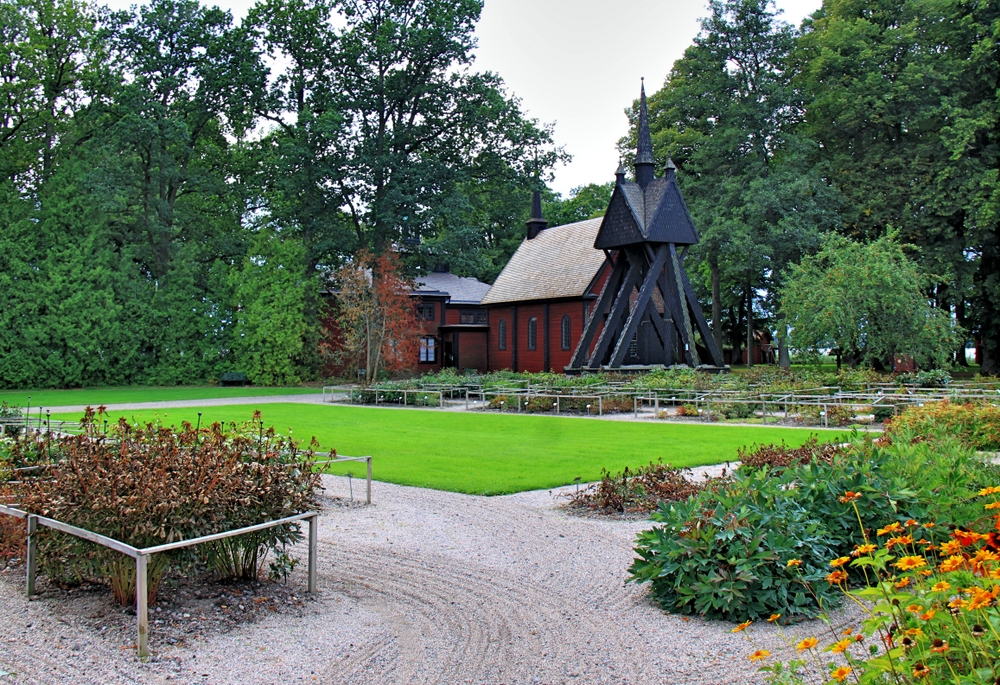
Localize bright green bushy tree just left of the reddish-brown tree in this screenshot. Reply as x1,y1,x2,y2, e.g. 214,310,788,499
228,228,315,385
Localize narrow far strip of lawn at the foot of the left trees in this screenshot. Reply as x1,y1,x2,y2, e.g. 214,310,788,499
0,385,321,409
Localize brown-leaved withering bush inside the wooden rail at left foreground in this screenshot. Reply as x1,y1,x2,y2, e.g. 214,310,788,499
15,410,319,605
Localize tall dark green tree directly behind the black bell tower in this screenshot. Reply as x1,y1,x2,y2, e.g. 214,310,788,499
636,0,839,358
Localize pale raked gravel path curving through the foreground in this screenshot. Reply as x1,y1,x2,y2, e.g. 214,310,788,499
0,476,860,685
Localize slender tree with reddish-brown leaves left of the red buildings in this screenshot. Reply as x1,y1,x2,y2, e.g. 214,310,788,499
336,250,417,383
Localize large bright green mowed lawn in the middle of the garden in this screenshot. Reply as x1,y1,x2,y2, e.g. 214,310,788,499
56,404,844,495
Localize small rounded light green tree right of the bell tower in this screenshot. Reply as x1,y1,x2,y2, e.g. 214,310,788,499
781,232,955,368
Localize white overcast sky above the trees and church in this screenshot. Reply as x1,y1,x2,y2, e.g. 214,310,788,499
104,0,821,195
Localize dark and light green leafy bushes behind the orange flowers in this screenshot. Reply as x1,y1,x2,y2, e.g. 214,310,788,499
629,436,993,621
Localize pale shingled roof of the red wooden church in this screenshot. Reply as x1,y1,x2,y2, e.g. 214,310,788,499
482,218,605,304
